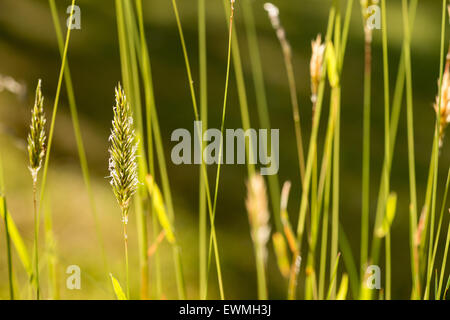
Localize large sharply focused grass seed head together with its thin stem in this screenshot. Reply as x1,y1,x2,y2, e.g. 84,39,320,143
109,83,139,298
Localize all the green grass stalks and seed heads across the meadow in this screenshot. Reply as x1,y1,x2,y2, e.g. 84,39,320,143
0,0,450,300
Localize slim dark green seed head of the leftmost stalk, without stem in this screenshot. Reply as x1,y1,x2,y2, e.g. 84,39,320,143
27,80,46,182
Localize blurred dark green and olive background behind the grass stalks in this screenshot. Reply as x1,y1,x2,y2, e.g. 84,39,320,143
0,0,450,299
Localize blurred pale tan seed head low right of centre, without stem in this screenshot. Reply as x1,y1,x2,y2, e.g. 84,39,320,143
245,174,270,262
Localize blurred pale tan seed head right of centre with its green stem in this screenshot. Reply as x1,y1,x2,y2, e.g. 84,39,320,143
245,174,270,300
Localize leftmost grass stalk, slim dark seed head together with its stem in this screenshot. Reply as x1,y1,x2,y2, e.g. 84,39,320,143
28,80,47,300
